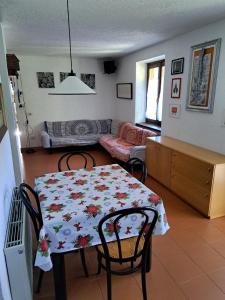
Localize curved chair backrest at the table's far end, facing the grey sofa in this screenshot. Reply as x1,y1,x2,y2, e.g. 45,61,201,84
58,151,96,172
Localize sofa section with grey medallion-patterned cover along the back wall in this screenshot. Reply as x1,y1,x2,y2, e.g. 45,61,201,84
41,119,112,150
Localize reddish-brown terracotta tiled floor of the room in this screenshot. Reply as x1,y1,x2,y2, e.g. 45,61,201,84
24,150,225,300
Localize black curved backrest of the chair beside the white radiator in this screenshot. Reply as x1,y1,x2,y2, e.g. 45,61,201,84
19,183,43,240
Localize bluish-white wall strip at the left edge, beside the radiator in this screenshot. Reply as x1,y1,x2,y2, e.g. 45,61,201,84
0,131,15,300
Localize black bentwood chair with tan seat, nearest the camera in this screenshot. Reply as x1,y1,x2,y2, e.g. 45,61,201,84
96,207,158,300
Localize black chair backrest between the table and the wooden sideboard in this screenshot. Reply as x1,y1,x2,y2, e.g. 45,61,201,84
125,157,146,183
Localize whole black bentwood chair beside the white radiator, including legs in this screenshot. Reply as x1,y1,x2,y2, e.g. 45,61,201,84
19,183,88,293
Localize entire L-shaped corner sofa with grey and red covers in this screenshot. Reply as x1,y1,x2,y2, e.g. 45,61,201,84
41,119,158,161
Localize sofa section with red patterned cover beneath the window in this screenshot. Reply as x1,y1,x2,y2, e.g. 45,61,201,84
99,122,158,162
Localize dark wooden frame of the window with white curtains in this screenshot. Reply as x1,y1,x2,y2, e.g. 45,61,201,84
145,59,165,127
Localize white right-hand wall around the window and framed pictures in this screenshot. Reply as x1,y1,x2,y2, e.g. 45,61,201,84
116,20,225,154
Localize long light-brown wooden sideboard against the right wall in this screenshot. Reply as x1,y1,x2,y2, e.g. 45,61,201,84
146,136,225,218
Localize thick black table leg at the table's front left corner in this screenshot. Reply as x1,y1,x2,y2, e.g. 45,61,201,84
52,253,67,300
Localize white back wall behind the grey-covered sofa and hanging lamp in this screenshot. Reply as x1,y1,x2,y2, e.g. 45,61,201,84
18,55,115,147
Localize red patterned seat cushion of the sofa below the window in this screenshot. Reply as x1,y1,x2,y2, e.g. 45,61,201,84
99,135,133,161
